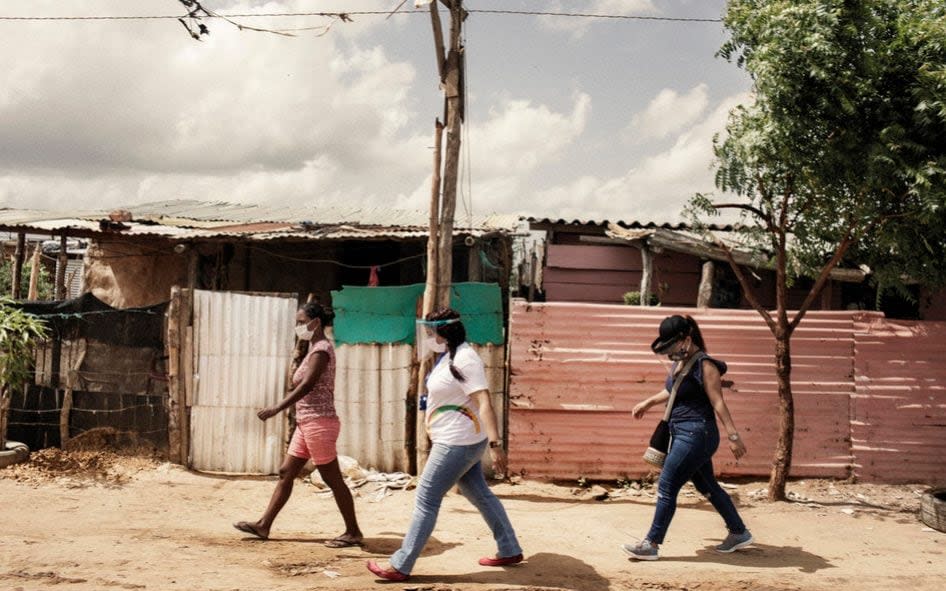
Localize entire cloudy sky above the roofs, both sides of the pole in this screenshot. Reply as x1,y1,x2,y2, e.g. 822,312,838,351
0,0,749,221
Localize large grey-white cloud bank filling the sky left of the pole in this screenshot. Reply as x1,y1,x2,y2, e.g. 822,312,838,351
0,0,429,212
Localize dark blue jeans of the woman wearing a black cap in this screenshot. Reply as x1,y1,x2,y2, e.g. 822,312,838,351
647,419,746,544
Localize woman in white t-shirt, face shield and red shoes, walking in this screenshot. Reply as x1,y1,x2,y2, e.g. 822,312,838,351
368,309,522,581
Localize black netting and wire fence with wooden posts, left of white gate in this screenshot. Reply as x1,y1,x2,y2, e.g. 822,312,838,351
9,293,168,449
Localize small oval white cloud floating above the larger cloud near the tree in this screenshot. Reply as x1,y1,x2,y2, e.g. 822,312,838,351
624,83,709,142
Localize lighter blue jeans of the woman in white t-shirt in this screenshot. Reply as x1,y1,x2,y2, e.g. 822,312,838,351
390,440,522,575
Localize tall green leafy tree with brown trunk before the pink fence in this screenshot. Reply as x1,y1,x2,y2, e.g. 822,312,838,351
691,0,946,500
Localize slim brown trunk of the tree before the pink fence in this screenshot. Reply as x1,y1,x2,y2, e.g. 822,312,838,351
769,326,795,501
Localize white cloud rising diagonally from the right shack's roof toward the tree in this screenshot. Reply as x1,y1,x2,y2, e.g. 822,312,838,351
535,94,748,222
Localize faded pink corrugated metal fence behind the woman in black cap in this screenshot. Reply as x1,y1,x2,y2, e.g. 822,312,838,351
509,300,946,482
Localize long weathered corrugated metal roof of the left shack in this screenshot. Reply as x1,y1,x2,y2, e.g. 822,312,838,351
0,200,520,240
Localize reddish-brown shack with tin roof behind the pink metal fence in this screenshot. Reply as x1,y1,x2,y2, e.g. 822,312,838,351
529,218,867,310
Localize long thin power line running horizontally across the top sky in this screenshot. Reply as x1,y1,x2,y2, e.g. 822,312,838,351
0,8,723,23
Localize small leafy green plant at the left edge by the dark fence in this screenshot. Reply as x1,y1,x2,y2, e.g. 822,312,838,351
0,298,46,449
